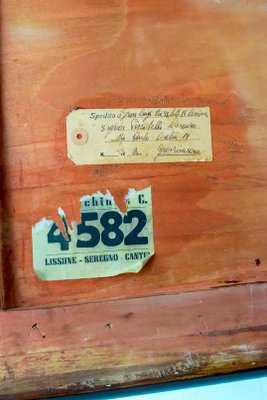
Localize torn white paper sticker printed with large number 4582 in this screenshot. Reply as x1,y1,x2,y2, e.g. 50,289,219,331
32,187,154,280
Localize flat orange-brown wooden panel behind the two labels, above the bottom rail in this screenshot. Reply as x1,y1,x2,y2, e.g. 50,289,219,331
2,0,267,307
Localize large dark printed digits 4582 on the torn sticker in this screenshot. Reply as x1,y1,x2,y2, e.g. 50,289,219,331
47,210,148,250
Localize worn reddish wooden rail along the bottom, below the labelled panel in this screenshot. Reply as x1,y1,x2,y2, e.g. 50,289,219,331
0,284,267,400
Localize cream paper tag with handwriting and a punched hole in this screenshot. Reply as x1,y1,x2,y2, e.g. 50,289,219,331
67,107,212,165
